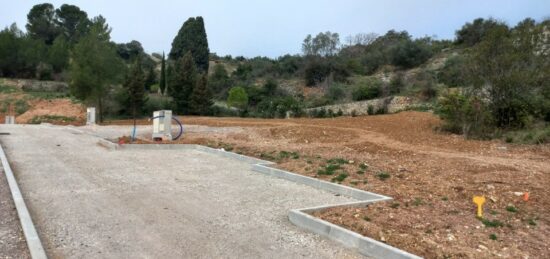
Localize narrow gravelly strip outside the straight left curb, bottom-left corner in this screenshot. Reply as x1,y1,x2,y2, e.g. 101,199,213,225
0,166,30,259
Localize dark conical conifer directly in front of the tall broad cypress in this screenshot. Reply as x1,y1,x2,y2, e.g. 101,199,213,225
168,52,201,113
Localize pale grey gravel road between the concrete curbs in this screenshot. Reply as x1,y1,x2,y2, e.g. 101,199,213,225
0,125,359,258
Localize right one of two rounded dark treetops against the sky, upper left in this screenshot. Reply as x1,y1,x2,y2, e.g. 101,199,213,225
55,4,90,44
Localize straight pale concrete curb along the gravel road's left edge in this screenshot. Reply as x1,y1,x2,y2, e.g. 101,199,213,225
0,145,48,259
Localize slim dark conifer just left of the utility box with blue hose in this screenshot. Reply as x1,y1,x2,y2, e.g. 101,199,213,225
123,58,146,119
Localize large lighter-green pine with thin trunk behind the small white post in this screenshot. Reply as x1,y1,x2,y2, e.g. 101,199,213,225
69,17,124,122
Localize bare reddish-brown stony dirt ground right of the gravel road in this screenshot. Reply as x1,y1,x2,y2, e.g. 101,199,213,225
106,112,550,258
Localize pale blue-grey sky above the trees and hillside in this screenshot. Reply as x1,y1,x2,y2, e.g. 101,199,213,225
0,0,550,57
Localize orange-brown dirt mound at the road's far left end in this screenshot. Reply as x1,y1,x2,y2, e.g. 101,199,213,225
15,99,86,124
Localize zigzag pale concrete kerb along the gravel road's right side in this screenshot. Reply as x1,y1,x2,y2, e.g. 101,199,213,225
114,143,421,259
